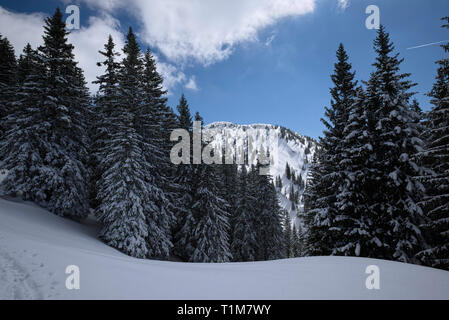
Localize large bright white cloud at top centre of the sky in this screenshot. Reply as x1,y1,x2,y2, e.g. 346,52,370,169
74,0,316,65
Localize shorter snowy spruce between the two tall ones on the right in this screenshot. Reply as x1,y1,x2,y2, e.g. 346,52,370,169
334,87,372,257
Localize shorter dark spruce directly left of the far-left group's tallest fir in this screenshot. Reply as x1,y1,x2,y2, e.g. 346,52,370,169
0,44,47,201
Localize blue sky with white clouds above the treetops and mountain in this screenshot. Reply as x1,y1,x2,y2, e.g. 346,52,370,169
0,0,449,137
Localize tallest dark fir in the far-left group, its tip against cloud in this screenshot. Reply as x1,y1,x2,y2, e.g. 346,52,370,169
35,8,89,218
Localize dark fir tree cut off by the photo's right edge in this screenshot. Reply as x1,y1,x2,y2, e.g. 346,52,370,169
418,17,449,270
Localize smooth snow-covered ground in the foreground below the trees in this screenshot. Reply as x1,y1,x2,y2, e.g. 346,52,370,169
0,199,449,299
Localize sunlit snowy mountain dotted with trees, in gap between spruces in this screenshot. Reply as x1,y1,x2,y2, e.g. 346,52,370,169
205,122,316,228
